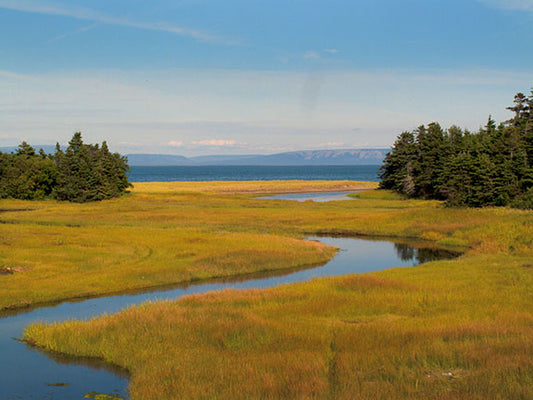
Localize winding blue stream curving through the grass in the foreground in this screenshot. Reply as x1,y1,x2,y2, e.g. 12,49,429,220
0,193,457,400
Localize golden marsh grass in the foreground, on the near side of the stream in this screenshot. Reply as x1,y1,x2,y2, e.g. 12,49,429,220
26,257,533,400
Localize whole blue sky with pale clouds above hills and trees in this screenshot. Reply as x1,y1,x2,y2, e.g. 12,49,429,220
0,0,533,156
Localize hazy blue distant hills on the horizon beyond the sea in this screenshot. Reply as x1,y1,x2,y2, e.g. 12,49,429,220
127,149,389,166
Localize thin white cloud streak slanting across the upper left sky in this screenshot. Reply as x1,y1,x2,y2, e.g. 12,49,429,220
0,0,236,45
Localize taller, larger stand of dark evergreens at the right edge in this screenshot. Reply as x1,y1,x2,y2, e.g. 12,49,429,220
379,91,533,209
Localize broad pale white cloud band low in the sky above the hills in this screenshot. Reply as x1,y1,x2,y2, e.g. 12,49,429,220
0,69,533,155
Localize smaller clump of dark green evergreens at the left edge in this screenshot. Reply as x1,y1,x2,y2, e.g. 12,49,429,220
0,132,131,203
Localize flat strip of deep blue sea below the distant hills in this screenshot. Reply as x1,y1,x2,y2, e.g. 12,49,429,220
128,165,379,182
